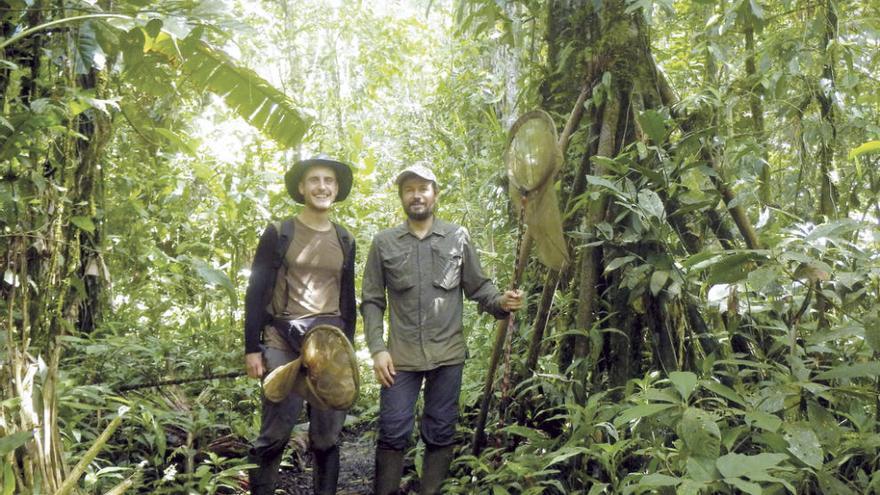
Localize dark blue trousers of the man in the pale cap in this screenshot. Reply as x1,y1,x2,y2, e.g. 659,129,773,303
378,364,464,450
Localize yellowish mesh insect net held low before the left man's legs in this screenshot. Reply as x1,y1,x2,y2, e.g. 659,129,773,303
263,325,360,410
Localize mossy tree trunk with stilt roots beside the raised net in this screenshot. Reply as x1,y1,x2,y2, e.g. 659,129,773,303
520,0,760,396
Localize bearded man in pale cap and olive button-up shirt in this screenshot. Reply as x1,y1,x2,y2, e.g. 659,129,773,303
361,165,522,495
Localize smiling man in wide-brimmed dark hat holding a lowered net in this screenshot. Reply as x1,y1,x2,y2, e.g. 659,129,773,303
244,155,357,495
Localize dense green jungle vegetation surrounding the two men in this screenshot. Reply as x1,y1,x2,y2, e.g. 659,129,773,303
0,0,880,495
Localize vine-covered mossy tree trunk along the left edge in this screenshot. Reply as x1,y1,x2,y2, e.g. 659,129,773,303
0,6,111,493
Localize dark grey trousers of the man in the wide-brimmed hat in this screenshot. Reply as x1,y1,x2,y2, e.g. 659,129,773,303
249,317,346,495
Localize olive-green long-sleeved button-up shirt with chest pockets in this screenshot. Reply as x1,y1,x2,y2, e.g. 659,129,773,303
361,218,508,371
